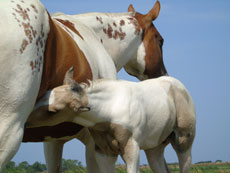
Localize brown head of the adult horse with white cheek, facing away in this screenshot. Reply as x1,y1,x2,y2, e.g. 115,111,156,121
125,1,167,80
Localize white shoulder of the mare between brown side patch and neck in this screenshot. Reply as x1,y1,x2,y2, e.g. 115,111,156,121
54,15,117,79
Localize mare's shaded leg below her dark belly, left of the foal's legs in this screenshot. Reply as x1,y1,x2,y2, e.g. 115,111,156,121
43,141,66,173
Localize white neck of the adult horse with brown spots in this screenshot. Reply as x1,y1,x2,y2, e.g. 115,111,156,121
75,13,142,71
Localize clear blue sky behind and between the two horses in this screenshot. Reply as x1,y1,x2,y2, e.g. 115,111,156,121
13,0,230,164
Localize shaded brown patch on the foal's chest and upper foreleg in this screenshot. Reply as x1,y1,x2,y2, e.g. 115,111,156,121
89,122,132,156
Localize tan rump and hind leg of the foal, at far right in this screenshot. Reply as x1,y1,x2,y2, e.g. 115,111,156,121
169,82,196,173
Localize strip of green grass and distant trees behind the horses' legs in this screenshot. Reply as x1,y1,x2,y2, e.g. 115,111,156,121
3,160,230,173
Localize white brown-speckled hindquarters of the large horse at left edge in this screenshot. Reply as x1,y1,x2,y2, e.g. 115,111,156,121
0,0,49,172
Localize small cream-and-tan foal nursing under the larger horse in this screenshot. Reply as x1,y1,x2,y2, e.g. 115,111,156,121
27,70,196,173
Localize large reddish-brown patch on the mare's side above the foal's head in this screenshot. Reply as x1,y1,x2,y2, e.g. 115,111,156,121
38,13,93,98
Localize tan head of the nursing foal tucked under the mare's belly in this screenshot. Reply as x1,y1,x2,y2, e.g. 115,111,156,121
26,68,89,128
